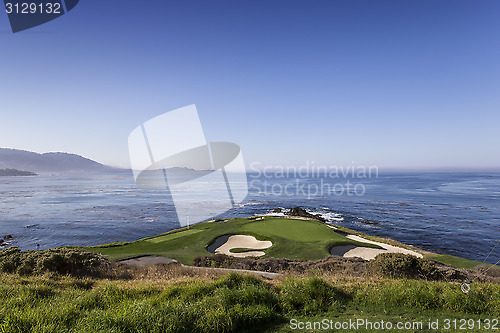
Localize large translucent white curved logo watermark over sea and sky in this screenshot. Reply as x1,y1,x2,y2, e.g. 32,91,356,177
128,104,248,227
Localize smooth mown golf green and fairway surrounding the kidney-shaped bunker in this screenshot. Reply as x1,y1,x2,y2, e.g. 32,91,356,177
86,217,378,264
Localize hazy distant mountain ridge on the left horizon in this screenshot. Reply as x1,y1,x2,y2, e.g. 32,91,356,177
0,148,125,173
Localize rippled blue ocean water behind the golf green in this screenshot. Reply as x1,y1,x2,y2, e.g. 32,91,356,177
0,173,500,263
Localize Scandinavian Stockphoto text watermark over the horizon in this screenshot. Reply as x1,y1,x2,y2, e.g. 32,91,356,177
248,161,379,199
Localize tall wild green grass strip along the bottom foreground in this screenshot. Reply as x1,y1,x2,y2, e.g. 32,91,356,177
0,274,500,333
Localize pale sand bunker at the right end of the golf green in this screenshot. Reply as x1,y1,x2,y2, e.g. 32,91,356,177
331,235,423,260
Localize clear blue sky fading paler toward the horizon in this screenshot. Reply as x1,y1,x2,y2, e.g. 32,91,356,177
0,0,500,169
